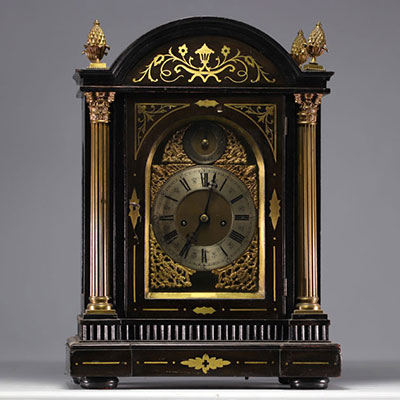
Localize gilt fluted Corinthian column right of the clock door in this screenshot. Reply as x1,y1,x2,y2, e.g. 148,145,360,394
294,93,322,314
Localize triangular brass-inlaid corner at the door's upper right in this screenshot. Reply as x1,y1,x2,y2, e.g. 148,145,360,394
225,103,277,162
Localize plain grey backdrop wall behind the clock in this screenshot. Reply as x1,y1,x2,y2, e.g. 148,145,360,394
0,0,400,361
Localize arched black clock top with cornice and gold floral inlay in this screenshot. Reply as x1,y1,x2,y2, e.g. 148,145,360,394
75,17,332,90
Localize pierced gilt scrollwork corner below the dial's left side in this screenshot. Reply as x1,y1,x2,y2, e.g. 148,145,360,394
150,228,196,289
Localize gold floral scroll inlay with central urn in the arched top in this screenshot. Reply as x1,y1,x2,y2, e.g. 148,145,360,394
132,43,275,83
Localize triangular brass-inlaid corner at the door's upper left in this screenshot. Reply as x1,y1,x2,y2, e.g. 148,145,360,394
134,103,190,158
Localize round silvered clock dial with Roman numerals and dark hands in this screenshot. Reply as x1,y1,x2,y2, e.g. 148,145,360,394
152,166,257,271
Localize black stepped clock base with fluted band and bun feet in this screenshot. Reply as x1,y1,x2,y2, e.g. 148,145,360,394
67,315,341,389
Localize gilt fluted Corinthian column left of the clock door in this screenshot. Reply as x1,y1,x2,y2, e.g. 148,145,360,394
85,92,115,314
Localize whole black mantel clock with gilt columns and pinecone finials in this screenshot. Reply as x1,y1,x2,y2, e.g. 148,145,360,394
67,17,340,388
